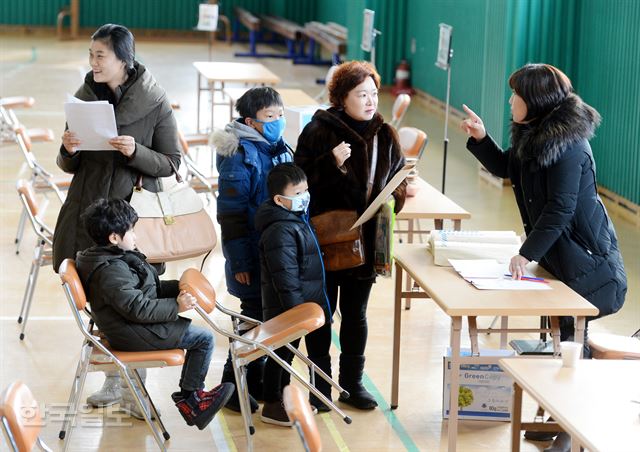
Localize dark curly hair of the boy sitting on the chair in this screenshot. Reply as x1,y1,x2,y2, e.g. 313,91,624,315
80,198,138,246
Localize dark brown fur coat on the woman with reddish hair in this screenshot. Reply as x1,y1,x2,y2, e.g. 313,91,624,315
293,108,407,278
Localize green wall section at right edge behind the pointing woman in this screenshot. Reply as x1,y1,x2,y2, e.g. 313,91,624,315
573,0,640,204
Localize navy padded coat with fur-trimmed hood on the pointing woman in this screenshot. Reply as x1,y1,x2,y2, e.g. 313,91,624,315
467,94,627,317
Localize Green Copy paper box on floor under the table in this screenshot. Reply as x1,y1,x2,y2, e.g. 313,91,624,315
442,349,514,421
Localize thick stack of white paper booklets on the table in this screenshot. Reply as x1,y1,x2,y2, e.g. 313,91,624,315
429,231,520,266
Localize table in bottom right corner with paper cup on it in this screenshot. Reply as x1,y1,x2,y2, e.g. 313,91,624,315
499,359,640,452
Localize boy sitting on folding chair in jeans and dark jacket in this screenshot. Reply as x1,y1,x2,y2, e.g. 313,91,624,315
76,199,235,430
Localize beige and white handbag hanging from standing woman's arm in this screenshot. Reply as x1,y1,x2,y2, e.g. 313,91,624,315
129,159,217,263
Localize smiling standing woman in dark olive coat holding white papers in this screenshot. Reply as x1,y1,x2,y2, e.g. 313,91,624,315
53,24,180,418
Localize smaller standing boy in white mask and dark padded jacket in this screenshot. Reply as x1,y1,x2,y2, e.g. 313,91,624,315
256,163,331,426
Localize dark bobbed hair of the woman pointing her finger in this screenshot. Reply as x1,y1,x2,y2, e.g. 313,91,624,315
509,63,573,121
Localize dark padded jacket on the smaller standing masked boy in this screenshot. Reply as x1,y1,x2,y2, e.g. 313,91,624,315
255,200,331,321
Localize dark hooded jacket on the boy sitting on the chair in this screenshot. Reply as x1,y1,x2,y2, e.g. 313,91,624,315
76,246,191,351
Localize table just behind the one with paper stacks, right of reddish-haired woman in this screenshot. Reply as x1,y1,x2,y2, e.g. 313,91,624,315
395,177,471,310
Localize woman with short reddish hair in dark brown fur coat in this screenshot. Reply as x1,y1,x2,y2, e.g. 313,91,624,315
294,61,406,409
